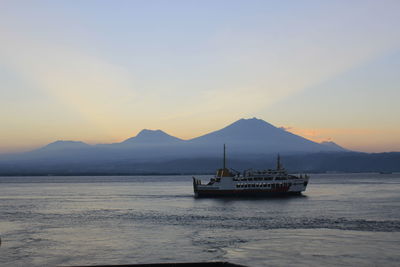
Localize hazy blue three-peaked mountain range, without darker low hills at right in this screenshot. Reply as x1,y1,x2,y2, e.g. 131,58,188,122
0,118,358,173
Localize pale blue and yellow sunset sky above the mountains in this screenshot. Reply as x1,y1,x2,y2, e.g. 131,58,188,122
0,0,400,153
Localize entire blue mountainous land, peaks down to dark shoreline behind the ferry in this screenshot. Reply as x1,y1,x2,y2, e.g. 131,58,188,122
0,118,400,175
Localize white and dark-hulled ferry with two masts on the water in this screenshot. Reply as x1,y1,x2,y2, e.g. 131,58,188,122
193,145,309,197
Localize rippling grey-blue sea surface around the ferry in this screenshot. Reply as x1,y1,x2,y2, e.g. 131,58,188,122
0,174,400,266
